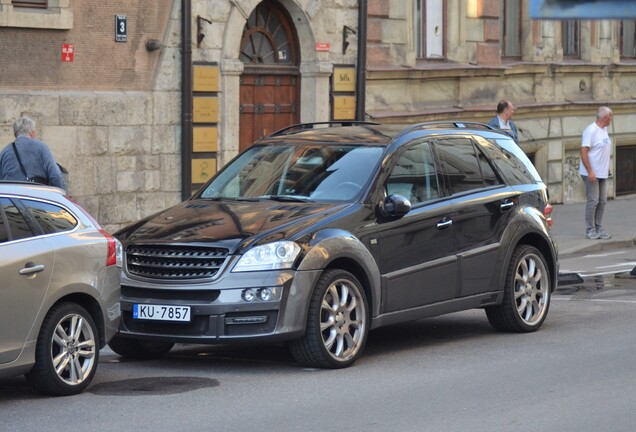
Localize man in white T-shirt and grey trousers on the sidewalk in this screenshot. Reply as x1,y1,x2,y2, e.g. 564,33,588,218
579,107,612,240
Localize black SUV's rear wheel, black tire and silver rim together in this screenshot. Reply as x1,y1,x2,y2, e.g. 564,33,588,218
486,245,552,333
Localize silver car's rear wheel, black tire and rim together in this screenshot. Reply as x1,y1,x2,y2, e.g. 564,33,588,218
26,302,100,396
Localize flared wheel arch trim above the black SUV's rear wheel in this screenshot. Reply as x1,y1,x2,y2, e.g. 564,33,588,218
499,207,558,291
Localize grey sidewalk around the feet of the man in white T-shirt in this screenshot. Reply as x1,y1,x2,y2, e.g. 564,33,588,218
552,195,636,258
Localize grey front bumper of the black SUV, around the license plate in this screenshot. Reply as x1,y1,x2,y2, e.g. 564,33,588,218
119,270,321,344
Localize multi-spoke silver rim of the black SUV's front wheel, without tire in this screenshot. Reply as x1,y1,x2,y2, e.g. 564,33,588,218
320,279,367,361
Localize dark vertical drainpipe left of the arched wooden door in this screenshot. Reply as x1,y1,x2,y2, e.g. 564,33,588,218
181,0,192,200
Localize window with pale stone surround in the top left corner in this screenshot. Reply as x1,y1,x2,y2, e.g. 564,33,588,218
0,0,73,30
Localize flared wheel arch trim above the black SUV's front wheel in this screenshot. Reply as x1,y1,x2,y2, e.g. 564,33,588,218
298,228,381,316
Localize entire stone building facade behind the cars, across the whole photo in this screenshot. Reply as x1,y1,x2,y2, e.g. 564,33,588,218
0,0,636,231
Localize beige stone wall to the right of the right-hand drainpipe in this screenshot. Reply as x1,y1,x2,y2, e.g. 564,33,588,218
366,0,636,203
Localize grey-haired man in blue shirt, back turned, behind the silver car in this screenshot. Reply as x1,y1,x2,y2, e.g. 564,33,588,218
0,116,66,189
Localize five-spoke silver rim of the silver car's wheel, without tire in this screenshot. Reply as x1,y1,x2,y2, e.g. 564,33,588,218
51,313,97,385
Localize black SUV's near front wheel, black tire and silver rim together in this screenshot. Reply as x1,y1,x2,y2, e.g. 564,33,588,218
289,269,369,369
